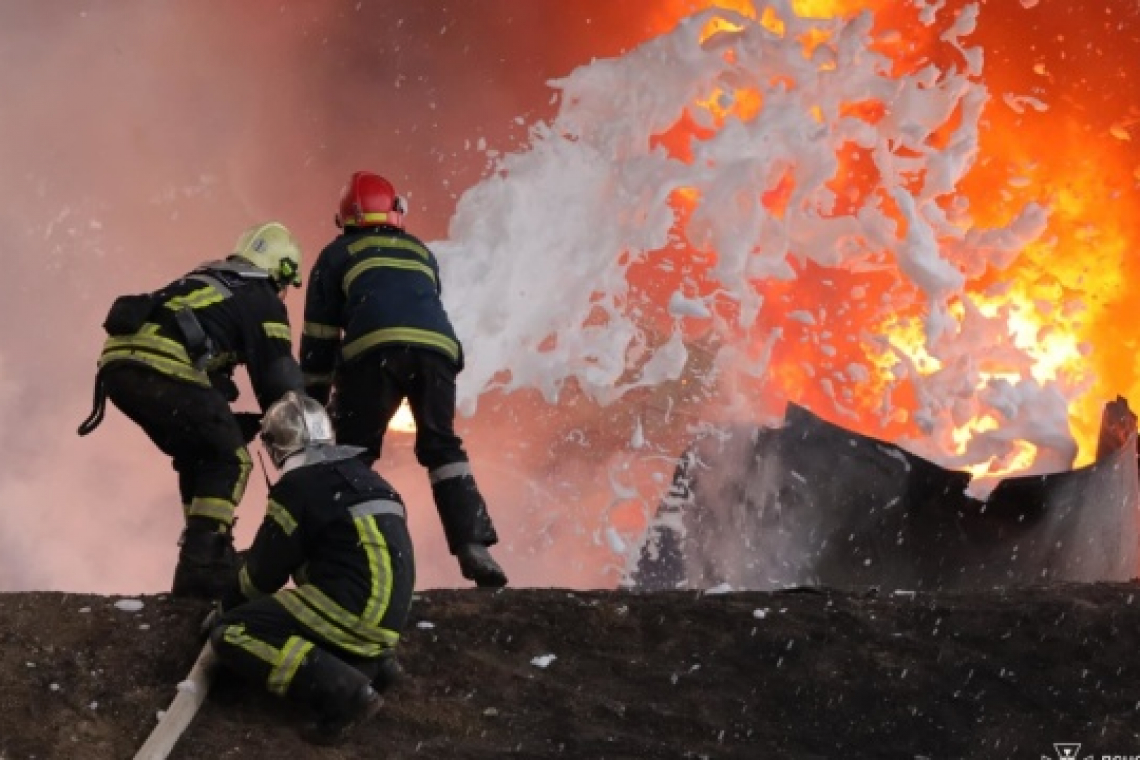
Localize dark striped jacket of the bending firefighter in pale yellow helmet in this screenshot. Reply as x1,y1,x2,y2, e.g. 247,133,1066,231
99,259,302,409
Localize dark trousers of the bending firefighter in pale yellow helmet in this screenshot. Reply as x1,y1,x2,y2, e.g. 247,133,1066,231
103,361,252,526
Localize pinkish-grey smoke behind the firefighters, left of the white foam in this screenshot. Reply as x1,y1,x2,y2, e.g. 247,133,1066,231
0,0,661,593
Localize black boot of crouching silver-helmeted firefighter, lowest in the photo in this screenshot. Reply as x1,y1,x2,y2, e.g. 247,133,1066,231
288,649,384,746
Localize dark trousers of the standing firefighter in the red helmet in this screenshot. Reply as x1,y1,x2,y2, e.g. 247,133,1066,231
329,346,498,554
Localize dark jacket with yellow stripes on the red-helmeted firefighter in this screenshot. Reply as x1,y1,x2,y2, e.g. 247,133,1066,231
301,227,463,398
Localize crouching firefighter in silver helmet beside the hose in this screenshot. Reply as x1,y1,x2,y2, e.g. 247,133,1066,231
207,392,415,744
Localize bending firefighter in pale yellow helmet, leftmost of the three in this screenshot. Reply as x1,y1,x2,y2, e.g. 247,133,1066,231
79,222,302,599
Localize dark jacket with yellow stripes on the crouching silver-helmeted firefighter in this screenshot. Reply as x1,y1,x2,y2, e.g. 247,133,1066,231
222,447,415,657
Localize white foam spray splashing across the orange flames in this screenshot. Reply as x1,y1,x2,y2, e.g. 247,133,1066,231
433,0,1075,494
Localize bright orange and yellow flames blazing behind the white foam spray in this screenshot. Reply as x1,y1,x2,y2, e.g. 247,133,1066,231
629,0,1140,479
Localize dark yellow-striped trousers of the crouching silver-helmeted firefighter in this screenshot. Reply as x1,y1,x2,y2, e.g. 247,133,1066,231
210,596,396,712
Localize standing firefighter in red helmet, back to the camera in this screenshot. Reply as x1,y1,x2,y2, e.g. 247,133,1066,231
301,172,507,587
